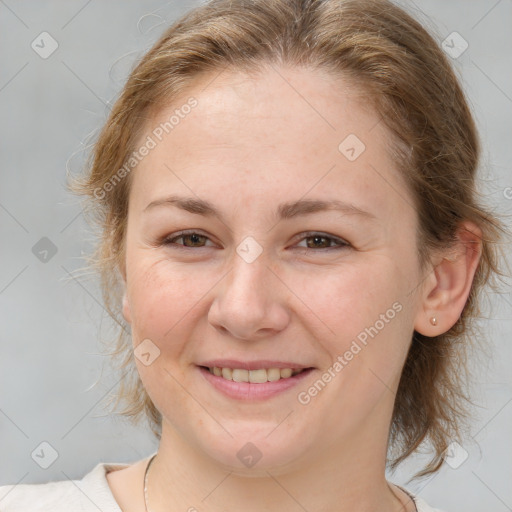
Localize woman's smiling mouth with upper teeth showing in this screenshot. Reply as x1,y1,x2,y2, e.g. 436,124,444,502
197,361,315,401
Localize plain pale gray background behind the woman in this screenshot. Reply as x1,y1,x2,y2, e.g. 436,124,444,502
0,0,512,512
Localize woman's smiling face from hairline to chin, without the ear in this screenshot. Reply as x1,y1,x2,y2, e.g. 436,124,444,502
124,67,421,471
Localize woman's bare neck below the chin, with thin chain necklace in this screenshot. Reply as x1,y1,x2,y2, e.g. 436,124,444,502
148,420,414,512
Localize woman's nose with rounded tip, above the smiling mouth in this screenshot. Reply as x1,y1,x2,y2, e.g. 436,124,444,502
208,255,290,341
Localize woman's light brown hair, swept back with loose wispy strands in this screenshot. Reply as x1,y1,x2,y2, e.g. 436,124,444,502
70,0,502,477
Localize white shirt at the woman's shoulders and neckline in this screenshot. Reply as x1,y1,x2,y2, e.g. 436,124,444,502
0,462,441,512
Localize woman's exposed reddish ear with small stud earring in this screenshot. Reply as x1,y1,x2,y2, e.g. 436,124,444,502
414,221,482,337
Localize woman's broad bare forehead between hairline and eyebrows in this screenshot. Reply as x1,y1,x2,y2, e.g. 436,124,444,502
133,66,407,223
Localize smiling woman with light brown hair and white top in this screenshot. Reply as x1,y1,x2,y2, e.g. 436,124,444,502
0,0,499,512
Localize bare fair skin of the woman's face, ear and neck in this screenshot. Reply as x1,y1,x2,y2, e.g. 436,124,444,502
107,66,479,512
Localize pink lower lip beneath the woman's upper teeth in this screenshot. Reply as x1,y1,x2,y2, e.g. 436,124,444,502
199,367,313,401
